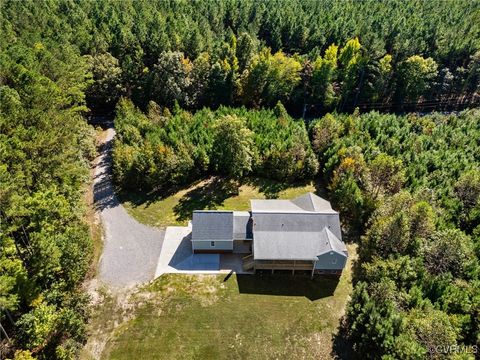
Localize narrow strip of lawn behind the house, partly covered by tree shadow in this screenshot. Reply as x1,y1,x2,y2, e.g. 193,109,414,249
120,177,315,227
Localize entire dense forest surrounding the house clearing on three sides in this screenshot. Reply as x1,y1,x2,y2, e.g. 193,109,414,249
0,0,480,359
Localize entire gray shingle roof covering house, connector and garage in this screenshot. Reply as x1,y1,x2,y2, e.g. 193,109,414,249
192,193,347,260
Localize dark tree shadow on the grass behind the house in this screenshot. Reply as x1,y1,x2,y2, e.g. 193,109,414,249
173,177,240,221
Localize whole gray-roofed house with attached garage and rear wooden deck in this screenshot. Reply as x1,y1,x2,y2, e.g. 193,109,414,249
191,193,348,276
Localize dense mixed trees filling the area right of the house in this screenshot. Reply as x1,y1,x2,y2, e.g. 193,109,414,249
309,110,480,359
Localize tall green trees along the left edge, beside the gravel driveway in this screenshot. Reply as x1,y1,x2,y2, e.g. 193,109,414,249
0,35,96,359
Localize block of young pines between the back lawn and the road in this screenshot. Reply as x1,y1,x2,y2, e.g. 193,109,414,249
113,99,318,191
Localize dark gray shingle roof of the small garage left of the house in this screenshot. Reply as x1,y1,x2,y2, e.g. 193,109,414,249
192,210,233,241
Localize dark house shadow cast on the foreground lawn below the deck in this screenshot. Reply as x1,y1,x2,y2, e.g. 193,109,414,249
237,272,339,301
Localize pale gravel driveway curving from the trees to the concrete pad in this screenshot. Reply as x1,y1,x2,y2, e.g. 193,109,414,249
94,126,165,286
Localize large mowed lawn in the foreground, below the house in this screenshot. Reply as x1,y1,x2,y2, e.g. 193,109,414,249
102,246,355,360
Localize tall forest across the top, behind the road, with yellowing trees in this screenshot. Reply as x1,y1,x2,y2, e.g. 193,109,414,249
1,0,480,117
